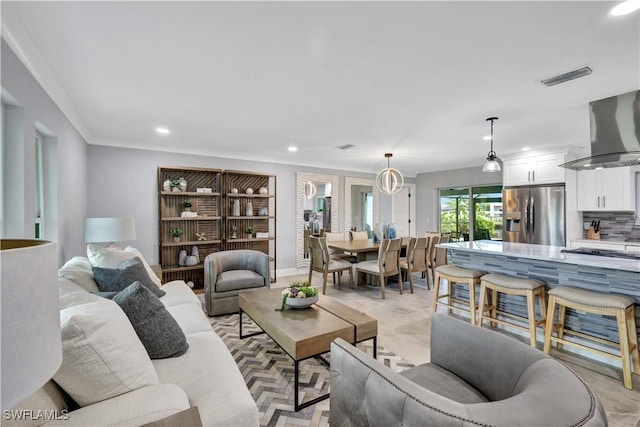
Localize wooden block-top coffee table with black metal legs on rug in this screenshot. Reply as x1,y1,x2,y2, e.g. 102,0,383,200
239,289,378,411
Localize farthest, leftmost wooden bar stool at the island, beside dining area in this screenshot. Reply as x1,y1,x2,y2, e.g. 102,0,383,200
433,265,486,325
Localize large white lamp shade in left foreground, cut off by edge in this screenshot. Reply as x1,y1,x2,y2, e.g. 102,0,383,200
0,239,62,410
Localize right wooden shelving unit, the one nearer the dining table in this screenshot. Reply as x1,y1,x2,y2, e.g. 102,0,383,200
222,170,277,282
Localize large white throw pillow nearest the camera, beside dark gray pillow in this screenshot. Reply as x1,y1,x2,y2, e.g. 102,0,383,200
53,298,159,406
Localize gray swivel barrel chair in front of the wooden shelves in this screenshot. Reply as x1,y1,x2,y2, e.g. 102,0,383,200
204,249,271,316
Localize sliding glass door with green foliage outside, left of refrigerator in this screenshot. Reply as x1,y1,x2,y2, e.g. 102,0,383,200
440,185,502,240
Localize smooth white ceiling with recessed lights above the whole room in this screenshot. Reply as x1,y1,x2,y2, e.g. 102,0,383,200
2,1,640,176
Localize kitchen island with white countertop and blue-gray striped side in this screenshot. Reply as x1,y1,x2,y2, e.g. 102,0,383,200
437,240,640,357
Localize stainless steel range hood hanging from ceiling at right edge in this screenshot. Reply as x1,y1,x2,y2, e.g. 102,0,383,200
560,90,640,171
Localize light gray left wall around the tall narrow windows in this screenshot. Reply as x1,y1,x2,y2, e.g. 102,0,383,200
0,40,87,263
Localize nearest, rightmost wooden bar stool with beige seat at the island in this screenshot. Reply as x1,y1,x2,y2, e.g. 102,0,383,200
543,286,640,390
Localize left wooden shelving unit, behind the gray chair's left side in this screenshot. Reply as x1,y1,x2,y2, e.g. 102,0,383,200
158,166,223,292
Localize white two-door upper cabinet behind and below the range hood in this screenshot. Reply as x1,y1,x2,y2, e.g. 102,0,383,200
578,167,636,211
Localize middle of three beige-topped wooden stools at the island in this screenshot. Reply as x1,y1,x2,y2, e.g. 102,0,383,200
478,274,547,348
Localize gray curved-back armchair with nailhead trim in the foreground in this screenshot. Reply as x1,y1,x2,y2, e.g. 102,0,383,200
329,313,607,427
